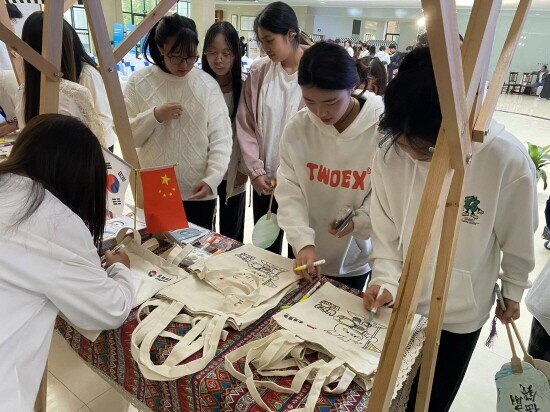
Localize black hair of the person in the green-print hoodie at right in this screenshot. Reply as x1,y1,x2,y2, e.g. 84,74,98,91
379,47,442,155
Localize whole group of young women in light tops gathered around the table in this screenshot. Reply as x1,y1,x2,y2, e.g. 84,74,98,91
0,2,538,412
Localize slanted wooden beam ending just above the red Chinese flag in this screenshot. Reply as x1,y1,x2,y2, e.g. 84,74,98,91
84,0,141,205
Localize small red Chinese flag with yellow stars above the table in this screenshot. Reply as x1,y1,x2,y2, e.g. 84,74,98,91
140,166,189,233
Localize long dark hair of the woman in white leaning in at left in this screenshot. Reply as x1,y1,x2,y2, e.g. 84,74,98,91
0,114,107,250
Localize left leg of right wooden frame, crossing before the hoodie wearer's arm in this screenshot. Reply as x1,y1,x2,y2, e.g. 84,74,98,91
367,131,453,412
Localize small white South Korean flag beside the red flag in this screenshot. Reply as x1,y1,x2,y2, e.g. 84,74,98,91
103,148,132,218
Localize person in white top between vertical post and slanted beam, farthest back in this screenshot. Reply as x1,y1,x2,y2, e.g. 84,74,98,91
63,20,117,152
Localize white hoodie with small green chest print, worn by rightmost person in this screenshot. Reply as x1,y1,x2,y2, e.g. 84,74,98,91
369,121,538,333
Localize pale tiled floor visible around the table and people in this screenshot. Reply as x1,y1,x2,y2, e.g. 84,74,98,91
48,95,550,412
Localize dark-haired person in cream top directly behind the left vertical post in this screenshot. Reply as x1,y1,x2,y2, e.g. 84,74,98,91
15,11,106,147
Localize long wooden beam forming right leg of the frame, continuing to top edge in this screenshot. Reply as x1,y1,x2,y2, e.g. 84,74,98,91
415,0,501,412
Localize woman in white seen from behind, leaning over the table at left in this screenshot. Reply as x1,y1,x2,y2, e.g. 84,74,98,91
0,114,141,411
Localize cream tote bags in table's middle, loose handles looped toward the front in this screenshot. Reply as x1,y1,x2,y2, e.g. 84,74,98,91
132,245,300,381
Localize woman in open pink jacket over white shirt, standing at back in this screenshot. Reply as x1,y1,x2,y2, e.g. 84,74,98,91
236,2,304,254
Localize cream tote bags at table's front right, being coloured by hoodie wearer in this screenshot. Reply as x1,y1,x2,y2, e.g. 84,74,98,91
225,283,420,411
